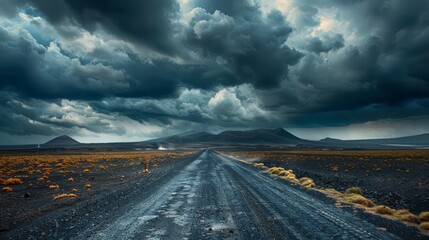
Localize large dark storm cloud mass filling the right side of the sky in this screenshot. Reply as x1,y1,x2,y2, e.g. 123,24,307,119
262,1,429,125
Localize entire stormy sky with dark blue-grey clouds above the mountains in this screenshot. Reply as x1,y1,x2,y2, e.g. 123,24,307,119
0,0,429,145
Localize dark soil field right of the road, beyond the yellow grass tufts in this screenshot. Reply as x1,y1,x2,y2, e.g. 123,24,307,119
222,150,429,214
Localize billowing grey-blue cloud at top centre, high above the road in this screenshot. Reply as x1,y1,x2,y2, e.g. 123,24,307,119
187,1,301,88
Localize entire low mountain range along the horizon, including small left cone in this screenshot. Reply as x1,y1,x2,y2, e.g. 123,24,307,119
36,128,429,149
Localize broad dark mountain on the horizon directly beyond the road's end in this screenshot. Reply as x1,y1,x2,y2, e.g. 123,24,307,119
165,128,305,144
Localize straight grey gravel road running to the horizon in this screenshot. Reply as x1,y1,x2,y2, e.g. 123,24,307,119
4,150,422,239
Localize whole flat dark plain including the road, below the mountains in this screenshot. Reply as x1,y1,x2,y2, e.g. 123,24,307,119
0,149,428,239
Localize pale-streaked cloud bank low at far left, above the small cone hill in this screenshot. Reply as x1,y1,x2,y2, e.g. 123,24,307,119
0,92,125,135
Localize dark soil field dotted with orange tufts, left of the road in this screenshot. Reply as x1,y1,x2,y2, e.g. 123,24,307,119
0,151,194,232
